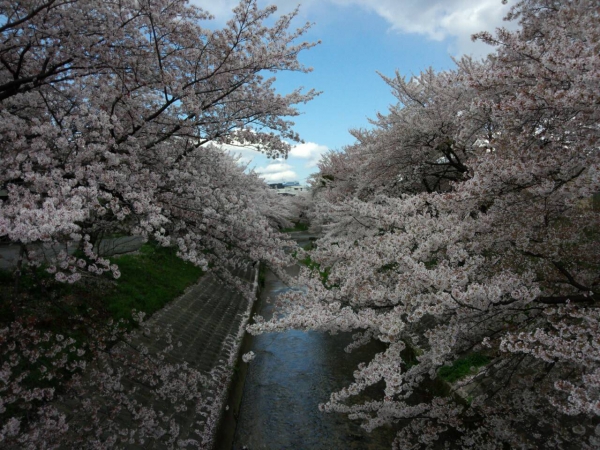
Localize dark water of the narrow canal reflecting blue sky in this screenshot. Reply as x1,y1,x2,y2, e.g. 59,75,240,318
233,236,393,450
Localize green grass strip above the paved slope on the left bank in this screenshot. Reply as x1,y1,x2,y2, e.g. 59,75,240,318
0,243,202,332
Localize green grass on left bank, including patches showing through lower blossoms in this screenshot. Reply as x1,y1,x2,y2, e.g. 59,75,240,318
0,244,202,430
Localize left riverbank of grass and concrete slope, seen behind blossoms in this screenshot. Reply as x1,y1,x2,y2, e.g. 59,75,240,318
0,245,258,449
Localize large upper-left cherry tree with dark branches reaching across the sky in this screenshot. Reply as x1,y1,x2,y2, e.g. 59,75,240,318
0,0,316,281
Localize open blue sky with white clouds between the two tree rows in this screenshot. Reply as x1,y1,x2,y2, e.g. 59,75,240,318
191,0,514,183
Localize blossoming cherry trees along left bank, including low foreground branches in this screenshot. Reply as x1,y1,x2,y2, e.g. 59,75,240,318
0,0,316,448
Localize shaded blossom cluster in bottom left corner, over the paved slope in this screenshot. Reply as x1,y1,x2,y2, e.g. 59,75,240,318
0,316,208,448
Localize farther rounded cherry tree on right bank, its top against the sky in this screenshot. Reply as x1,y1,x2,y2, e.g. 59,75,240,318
320,58,493,198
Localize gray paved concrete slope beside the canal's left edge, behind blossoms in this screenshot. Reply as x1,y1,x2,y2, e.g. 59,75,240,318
57,263,258,449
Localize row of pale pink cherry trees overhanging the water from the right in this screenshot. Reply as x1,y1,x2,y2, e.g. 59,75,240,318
250,0,600,449
